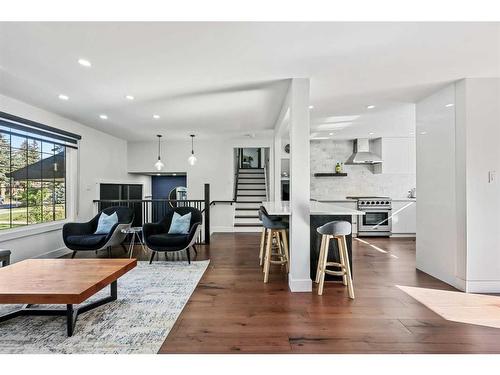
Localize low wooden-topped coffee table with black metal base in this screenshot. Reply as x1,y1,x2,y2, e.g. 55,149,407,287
0,259,137,336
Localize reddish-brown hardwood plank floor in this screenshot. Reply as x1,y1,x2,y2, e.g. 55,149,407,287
67,233,500,353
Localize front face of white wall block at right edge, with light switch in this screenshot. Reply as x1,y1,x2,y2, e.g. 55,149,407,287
457,78,500,292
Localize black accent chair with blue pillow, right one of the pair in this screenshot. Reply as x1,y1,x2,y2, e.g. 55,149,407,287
142,207,202,264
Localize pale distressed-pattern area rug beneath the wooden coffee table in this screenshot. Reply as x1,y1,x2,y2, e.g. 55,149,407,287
0,260,209,354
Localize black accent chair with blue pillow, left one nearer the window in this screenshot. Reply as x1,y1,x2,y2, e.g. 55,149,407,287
63,207,134,258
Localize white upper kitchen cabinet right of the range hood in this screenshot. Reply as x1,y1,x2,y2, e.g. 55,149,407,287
373,137,416,174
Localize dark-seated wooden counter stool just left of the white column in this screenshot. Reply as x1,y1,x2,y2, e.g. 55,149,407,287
259,207,289,283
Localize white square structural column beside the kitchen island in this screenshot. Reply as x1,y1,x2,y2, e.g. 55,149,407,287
288,78,312,292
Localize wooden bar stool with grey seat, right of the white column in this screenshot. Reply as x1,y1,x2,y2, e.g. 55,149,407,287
315,221,354,299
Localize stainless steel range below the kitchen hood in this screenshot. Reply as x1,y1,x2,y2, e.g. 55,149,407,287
347,197,392,237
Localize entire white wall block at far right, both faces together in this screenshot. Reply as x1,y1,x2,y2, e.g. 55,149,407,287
417,78,500,292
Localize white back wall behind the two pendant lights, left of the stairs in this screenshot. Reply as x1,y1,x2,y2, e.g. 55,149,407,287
127,134,272,232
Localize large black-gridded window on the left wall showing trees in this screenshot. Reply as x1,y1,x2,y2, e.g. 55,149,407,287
0,122,66,230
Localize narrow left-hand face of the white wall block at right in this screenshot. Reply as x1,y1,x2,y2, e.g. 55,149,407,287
416,85,464,287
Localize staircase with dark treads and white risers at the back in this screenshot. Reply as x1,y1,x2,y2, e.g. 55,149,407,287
234,169,267,232
